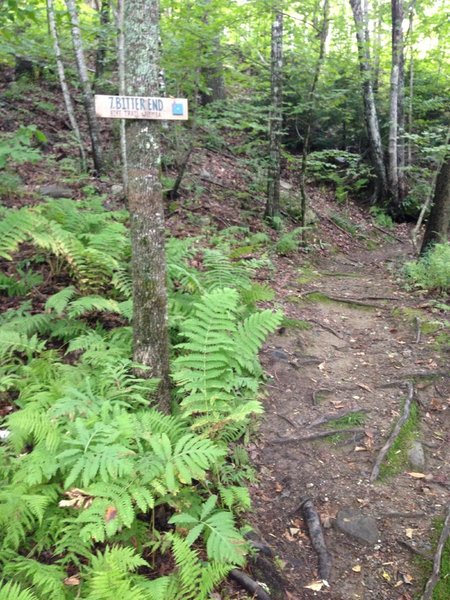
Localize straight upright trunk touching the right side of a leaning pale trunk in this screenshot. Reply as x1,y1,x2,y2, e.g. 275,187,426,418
388,0,403,217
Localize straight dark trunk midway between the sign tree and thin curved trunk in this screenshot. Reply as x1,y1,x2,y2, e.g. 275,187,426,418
265,7,283,219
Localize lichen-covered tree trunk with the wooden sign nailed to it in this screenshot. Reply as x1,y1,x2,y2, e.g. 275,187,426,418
124,0,170,412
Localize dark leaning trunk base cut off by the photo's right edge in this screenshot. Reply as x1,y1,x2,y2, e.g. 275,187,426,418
420,155,450,254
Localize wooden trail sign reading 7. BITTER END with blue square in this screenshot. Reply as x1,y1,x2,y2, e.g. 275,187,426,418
95,95,188,121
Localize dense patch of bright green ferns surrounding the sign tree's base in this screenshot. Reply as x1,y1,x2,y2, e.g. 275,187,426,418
0,201,282,600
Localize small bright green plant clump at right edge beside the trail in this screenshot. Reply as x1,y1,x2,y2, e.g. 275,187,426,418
405,244,450,292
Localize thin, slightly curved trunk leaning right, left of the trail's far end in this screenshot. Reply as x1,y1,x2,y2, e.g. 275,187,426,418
300,0,329,227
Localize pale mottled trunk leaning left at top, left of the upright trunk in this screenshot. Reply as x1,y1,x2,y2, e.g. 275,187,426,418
350,0,388,202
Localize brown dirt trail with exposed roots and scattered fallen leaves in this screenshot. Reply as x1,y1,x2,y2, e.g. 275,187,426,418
250,243,450,600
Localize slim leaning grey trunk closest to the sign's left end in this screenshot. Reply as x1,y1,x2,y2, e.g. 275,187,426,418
66,0,103,175
